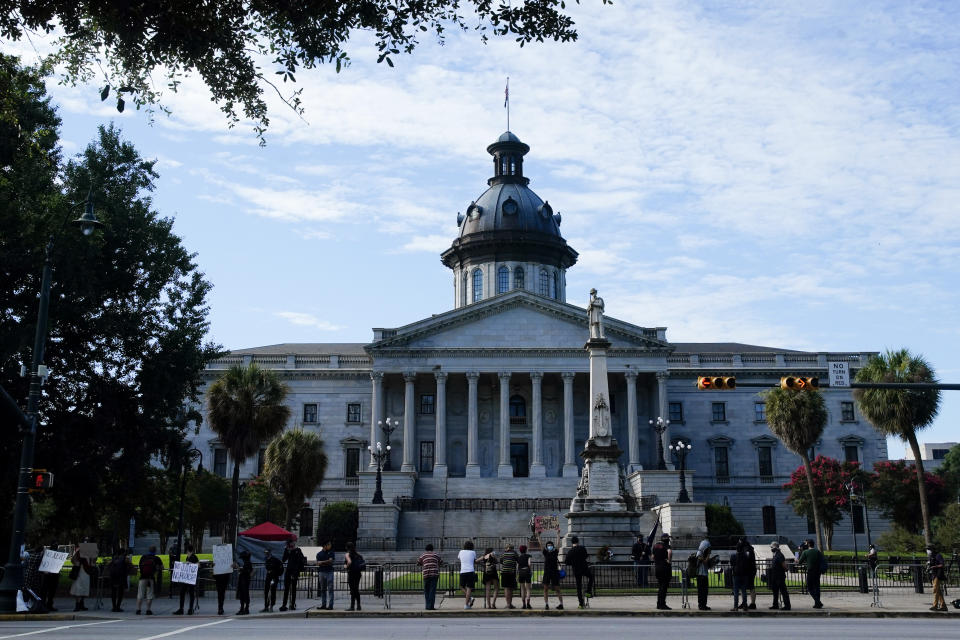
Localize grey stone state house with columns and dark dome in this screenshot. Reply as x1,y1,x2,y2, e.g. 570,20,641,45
194,132,887,549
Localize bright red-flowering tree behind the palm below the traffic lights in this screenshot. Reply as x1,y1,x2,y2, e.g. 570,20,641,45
783,456,866,551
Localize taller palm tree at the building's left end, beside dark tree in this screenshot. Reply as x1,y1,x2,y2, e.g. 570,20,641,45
207,364,290,543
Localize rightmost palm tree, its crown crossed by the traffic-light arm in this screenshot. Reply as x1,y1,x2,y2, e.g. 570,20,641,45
853,349,940,545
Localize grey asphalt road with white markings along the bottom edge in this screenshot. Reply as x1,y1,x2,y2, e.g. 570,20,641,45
0,617,960,640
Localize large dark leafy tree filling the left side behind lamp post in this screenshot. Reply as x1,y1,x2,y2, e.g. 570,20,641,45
0,56,220,548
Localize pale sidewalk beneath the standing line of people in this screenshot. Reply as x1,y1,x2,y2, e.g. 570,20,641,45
0,591,960,621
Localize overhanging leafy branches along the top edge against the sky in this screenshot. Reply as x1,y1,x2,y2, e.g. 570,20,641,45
0,0,610,137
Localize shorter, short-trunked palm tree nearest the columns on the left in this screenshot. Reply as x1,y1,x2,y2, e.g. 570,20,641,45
263,429,327,528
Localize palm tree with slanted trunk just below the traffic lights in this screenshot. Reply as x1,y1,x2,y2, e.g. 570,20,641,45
763,389,827,549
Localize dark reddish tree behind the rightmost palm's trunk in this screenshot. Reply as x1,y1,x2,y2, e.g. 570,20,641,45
869,460,947,544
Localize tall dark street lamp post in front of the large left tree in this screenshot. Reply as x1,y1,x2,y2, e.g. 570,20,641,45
0,193,102,613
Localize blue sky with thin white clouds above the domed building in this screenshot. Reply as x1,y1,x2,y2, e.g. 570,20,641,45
0,0,960,456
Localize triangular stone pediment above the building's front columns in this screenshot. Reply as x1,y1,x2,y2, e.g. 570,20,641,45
365,291,672,354
